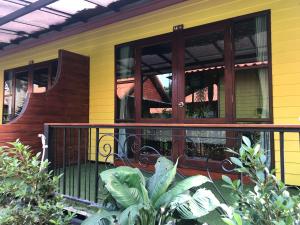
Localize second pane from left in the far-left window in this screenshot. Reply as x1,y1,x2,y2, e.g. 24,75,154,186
15,71,28,116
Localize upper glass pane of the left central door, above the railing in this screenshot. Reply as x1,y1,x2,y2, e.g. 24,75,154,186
141,43,173,118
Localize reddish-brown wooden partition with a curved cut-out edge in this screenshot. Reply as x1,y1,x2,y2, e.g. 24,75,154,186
0,50,89,151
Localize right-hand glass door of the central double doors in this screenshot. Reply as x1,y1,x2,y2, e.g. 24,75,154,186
178,28,226,168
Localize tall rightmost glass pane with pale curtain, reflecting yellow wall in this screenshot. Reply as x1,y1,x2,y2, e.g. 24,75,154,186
234,16,270,118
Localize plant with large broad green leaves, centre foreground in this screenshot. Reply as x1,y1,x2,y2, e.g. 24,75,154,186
83,157,224,225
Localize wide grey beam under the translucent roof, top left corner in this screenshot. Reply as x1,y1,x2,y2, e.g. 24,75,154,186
0,0,57,26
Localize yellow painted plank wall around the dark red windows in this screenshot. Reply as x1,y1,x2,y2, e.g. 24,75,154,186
0,0,300,185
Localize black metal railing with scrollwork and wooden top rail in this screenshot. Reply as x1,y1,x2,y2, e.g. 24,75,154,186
45,123,300,206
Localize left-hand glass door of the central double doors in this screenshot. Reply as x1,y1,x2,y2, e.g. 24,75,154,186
137,36,177,160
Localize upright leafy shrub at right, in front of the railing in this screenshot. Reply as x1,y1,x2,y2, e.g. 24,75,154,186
223,137,300,225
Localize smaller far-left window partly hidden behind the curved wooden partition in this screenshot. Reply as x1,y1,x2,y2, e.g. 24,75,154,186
2,60,57,123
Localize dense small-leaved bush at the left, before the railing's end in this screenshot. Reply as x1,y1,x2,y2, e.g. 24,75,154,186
0,140,72,225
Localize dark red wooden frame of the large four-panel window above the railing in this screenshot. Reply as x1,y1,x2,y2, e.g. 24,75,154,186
114,10,273,123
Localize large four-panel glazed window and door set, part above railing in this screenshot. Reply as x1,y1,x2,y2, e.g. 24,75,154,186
116,11,272,123
